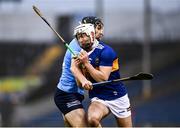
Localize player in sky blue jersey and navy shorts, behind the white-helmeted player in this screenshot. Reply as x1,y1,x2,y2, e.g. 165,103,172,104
54,16,103,127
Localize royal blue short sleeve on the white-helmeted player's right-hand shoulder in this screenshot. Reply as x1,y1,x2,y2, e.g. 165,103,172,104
100,47,117,66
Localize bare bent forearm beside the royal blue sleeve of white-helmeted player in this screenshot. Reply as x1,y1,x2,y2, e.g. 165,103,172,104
84,63,109,82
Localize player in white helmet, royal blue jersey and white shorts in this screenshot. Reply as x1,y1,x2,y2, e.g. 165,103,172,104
71,19,132,127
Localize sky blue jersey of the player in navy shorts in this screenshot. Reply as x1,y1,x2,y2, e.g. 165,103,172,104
57,39,84,95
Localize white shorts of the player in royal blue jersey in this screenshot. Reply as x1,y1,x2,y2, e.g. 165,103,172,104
91,94,131,118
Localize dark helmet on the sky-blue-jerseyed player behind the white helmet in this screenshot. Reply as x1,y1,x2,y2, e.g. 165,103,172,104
81,16,104,27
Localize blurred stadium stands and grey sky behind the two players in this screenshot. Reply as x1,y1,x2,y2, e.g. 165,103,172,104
0,0,180,127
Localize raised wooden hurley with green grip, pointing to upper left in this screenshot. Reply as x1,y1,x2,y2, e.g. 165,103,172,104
33,5,76,56
